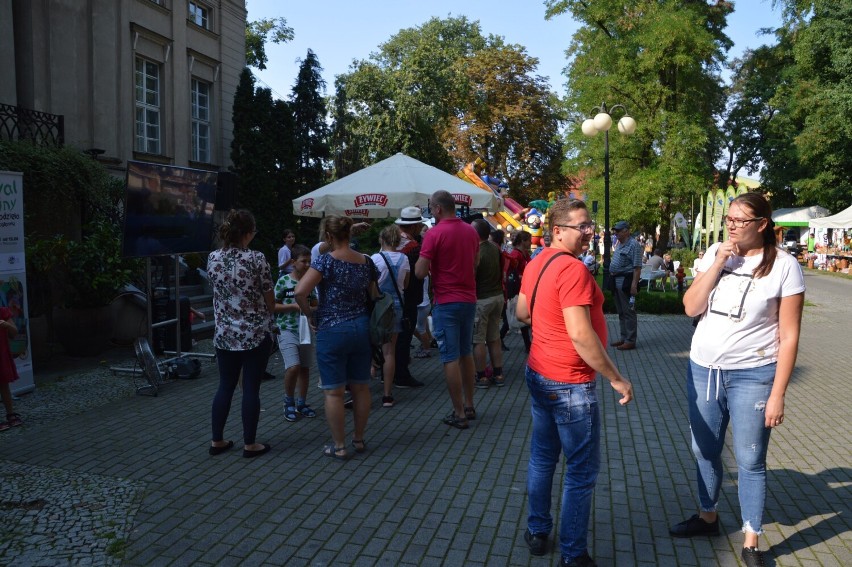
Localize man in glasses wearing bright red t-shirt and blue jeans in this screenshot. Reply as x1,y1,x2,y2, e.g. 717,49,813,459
517,199,633,567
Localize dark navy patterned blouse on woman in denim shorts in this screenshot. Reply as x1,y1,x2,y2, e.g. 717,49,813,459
311,254,373,331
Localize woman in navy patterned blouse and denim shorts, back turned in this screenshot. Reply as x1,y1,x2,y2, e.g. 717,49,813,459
294,217,376,460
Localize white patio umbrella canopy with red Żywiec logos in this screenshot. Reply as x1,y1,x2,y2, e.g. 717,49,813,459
293,154,502,219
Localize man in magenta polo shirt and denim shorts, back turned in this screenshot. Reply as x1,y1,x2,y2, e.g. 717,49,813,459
414,191,479,429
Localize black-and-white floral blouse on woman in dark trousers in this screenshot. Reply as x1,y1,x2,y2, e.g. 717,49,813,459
207,248,275,350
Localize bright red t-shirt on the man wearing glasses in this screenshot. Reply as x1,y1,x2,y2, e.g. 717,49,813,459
521,247,607,384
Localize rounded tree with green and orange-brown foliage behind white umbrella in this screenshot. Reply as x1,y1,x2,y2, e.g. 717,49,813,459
333,17,561,198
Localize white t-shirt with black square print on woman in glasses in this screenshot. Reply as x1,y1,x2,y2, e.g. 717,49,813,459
689,243,805,370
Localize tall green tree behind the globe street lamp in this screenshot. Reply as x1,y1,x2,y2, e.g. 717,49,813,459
545,0,732,251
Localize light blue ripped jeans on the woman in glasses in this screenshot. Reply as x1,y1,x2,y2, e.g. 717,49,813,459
687,360,776,535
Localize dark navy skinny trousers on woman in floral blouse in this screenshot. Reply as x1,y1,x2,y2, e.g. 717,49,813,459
211,337,272,445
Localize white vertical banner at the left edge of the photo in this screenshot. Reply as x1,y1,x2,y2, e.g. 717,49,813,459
0,171,35,394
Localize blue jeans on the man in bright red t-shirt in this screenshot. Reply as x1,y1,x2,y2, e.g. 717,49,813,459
526,367,601,560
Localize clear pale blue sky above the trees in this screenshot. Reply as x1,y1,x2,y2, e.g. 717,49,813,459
246,0,781,98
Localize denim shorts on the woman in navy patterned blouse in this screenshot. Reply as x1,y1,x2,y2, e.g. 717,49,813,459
317,315,373,390
